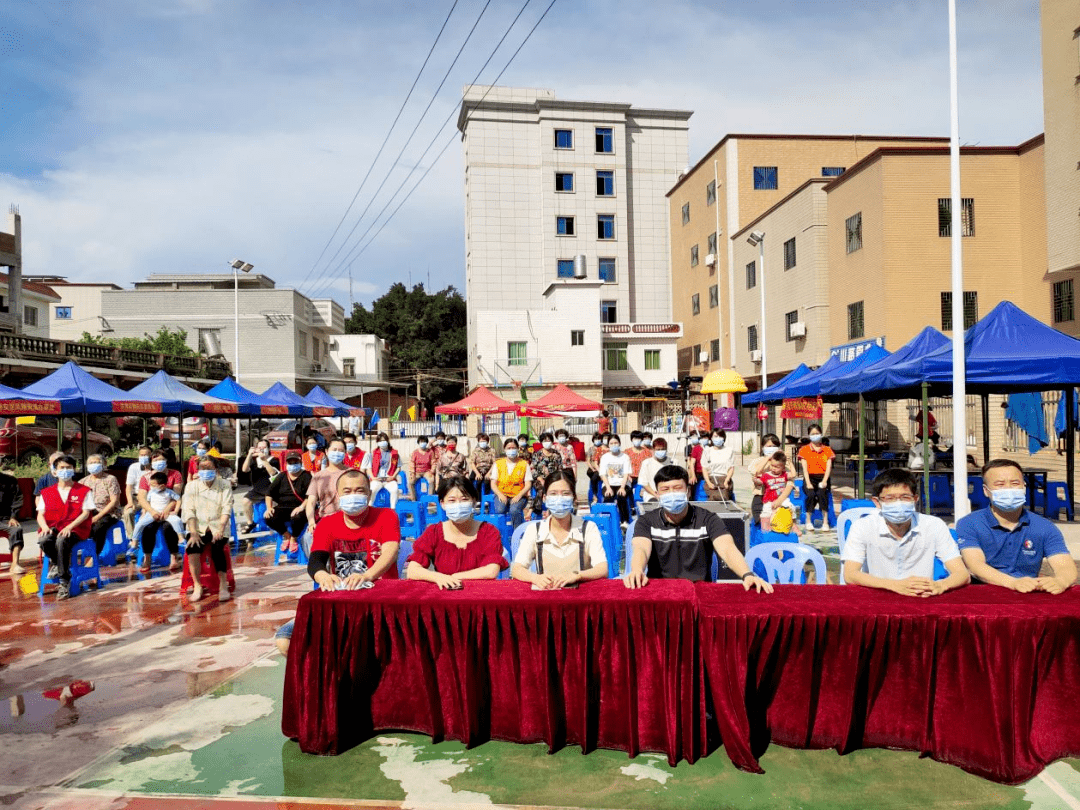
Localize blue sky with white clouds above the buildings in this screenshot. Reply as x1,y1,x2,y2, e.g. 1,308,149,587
0,0,1042,307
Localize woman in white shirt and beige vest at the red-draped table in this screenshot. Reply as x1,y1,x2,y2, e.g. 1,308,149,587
510,470,608,591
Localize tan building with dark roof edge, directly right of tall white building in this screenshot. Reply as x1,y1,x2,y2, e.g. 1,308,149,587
667,135,947,379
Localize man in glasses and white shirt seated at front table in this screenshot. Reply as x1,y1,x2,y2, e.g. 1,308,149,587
840,468,971,596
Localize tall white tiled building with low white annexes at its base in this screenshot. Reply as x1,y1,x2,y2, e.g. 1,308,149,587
458,86,691,395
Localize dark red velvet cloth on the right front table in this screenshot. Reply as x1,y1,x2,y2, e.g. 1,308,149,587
697,585,1080,784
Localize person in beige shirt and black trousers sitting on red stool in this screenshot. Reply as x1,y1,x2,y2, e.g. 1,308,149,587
183,457,232,602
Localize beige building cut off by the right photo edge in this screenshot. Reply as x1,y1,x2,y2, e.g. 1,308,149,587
1041,0,1080,336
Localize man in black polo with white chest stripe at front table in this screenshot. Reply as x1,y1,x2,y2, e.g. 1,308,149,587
623,464,772,593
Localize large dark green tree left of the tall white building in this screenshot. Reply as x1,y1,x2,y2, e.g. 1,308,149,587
345,282,468,406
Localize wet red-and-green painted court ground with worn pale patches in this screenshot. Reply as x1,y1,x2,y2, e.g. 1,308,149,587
6,475,1080,810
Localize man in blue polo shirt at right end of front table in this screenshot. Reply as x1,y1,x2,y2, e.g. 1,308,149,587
956,459,1077,594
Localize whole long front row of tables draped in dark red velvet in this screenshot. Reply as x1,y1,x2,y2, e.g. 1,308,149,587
282,580,1080,784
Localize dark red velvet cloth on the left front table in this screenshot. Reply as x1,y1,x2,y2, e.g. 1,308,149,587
282,580,704,765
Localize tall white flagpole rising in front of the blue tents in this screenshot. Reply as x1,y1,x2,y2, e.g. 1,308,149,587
954,0,971,521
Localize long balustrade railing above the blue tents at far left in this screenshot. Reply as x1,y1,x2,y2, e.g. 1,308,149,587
0,334,231,380
